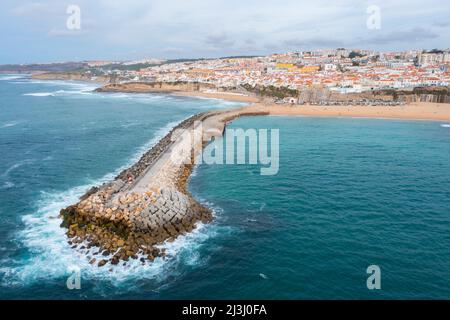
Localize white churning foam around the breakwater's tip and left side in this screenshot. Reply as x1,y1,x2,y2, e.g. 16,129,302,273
0,118,229,295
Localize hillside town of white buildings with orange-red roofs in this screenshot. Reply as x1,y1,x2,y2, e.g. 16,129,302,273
89,48,450,93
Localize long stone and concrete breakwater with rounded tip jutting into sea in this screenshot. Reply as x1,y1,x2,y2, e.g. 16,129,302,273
61,107,268,267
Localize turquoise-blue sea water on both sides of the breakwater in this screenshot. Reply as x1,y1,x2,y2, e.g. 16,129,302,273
0,75,450,299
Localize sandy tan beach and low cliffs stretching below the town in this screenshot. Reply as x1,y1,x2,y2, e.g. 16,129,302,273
33,73,450,121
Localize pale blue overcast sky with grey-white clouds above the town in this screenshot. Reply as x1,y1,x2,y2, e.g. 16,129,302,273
0,0,450,64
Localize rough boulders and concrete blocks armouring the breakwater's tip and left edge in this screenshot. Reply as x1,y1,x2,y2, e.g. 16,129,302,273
61,114,212,267
